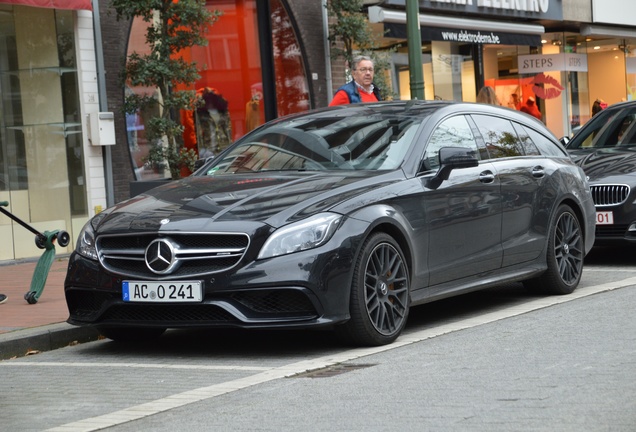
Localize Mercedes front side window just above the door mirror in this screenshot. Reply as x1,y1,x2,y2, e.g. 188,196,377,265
424,116,479,169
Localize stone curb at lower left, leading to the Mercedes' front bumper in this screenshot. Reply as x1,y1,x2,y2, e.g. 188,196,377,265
0,323,99,360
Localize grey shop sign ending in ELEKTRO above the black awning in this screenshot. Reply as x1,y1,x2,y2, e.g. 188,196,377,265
383,0,563,21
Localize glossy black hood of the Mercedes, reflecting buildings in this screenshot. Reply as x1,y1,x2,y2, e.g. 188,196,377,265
99,171,404,233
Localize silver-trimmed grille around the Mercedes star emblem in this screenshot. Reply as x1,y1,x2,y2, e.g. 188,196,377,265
96,232,250,280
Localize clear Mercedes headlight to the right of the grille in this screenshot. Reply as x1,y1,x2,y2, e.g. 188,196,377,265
257,213,342,259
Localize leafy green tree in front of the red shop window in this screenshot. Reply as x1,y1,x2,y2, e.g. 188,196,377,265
112,0,221,179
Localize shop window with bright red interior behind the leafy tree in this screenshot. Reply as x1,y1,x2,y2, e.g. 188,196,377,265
126,0,310,179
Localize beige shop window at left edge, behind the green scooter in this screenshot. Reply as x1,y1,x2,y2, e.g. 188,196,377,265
0,5,87,260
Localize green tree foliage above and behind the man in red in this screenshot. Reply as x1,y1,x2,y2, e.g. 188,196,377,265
327,0,392,99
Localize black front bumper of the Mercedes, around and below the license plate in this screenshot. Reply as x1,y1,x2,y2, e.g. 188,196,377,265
64,223,366,328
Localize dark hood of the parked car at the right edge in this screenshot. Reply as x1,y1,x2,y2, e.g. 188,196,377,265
570,147,636,183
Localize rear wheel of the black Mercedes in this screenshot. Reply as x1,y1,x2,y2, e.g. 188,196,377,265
524,204,585,295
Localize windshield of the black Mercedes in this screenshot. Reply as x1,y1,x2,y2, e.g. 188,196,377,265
203,114,422,175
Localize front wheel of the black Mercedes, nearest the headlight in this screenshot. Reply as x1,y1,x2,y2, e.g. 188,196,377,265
337,233,410,346
